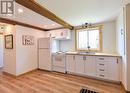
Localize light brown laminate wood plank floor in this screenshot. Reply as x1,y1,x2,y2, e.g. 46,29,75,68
0,70,125,93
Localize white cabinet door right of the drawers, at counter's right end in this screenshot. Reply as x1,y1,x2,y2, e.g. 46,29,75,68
107,58,120,81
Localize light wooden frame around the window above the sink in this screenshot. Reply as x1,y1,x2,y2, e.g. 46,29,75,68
75,25,102,52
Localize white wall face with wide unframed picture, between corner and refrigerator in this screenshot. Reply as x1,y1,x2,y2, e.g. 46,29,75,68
16,25,45,75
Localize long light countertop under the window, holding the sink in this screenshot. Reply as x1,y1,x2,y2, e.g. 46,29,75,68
66,52,121,57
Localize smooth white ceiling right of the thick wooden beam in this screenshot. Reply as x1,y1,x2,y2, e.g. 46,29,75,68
35,0,122,26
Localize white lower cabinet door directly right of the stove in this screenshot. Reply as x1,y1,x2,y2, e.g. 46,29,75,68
66,55,75,73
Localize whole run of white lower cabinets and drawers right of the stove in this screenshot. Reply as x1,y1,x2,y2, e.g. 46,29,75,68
66,55,120,81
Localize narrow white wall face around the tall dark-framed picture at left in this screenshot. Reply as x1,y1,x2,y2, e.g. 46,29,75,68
3,25,16,75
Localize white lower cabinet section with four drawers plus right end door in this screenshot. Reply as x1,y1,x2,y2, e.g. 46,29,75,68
96,57,120,81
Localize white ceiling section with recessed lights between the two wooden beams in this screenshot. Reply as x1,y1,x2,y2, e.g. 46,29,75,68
0,3,63,29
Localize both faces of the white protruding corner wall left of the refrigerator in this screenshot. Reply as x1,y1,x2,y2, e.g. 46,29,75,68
4,25,45,75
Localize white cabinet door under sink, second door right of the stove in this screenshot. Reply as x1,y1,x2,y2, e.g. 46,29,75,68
75,55,85,74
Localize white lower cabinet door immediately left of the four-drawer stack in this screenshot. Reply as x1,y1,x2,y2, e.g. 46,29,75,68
85,56,96,76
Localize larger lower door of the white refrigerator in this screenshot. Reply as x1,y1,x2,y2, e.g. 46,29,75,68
39,49,51,70
